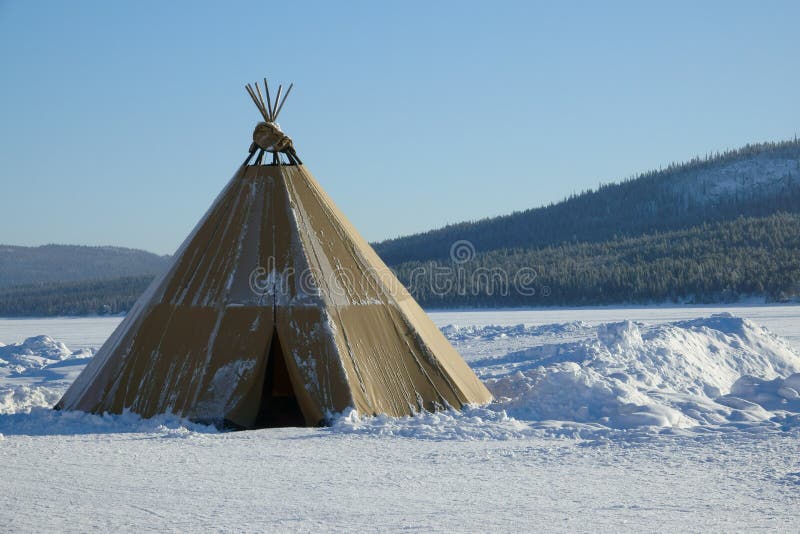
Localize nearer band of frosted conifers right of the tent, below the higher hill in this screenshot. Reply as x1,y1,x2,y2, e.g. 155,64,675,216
394,213,800,307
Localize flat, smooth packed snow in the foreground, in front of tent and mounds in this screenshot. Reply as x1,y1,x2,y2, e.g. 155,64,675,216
0,422,800,532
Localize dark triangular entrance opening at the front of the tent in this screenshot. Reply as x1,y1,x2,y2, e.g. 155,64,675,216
253,330,306,428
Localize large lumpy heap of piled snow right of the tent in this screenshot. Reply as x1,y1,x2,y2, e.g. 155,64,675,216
473,314,800,429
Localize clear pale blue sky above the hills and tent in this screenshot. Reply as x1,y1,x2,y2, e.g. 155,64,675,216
0,0,800,253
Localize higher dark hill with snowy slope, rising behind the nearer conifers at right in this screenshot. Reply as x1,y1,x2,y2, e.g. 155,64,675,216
374,139,800,265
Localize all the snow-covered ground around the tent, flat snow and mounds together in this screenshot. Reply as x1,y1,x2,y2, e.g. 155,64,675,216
0,306,800,531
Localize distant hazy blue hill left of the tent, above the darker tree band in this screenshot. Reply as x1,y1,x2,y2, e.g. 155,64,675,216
0,245,170,287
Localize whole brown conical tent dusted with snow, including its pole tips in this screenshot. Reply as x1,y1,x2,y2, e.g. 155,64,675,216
56,80,491,428
